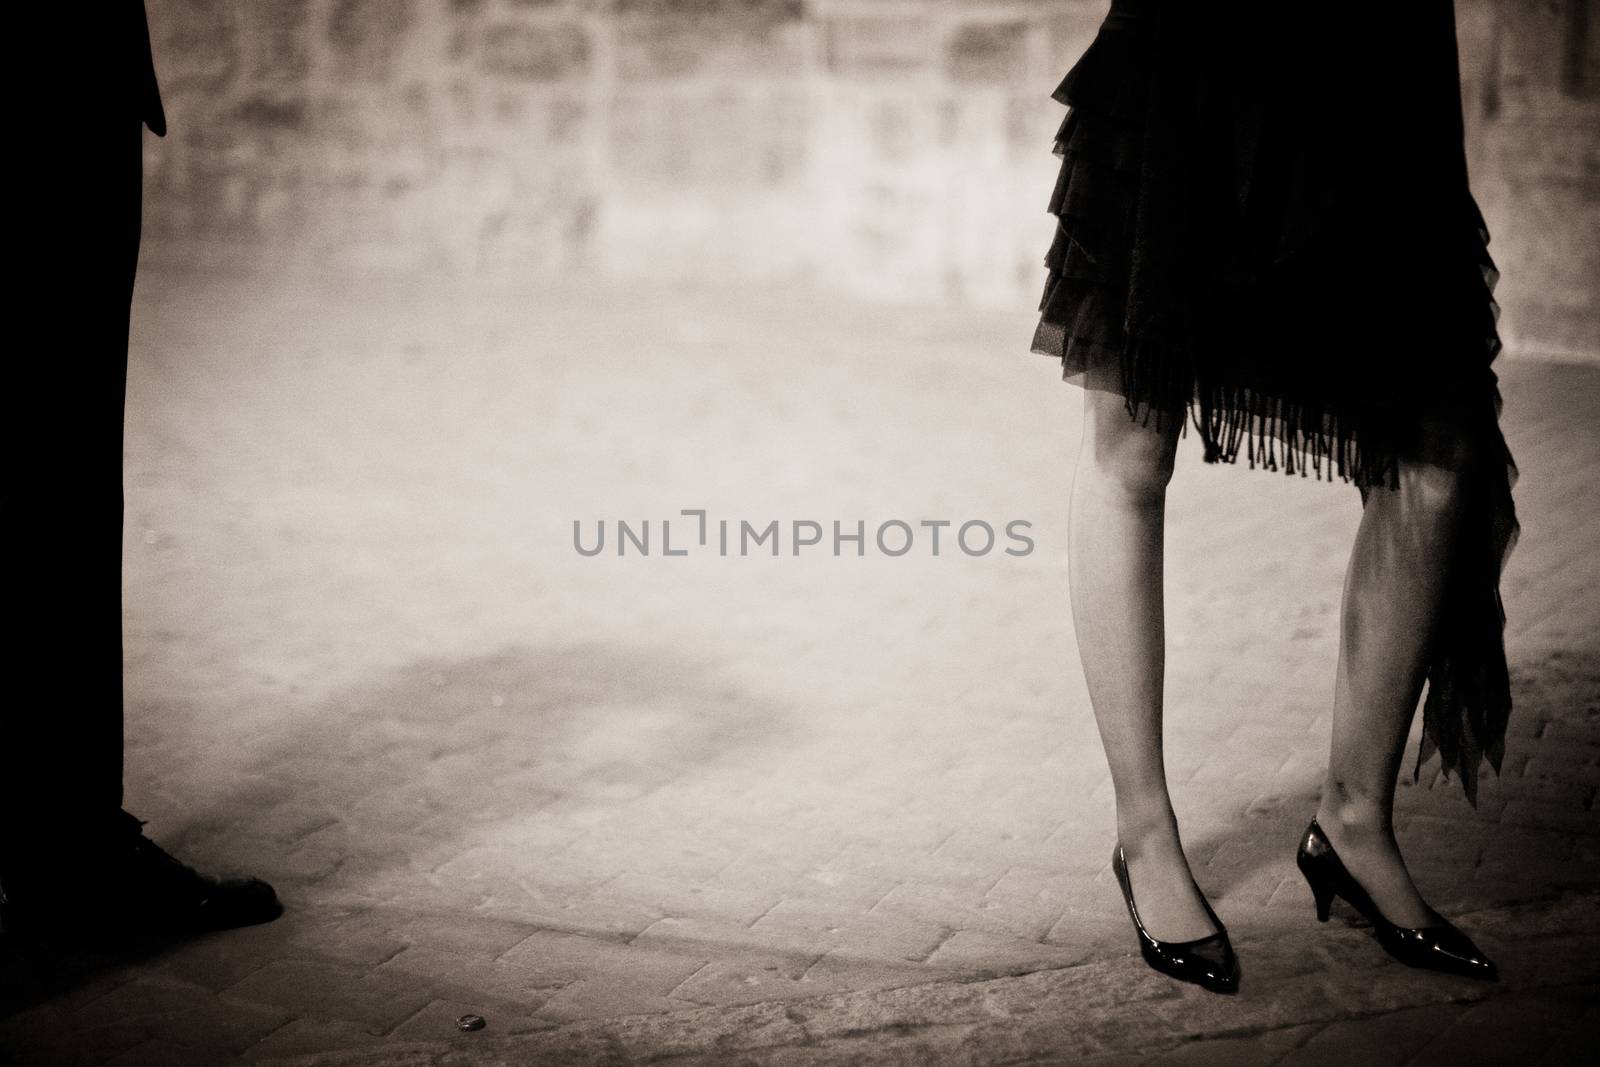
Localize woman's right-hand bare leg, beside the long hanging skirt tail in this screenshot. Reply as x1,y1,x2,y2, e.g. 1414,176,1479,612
1317,415,1469,926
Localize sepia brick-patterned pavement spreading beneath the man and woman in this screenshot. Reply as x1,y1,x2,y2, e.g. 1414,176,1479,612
0,277,1600,1064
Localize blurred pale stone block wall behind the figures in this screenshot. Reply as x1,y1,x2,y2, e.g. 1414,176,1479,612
146,0,1600,358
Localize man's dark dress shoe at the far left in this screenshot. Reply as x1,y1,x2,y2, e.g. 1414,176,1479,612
5,813,283,939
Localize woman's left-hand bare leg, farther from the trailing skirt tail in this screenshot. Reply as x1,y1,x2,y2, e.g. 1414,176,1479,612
1067,366,1216,941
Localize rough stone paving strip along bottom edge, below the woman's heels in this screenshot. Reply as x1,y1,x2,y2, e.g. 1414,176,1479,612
233,894,1600,1067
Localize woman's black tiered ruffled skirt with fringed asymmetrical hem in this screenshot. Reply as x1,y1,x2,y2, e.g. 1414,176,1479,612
1032,0,1518,805
